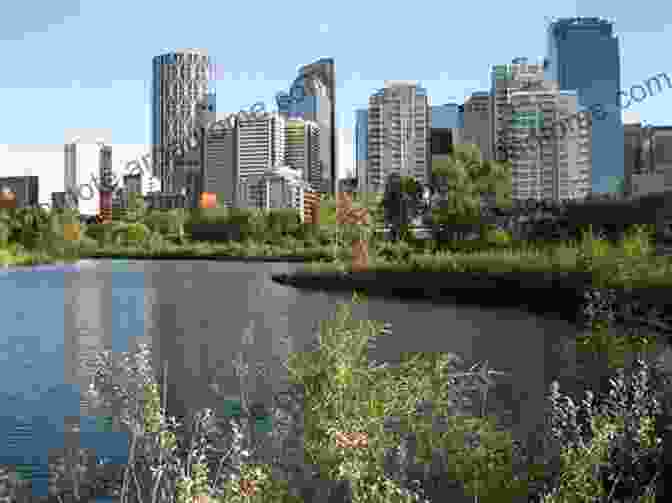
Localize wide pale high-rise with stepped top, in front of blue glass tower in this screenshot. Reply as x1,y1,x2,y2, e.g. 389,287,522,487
490,58,591,200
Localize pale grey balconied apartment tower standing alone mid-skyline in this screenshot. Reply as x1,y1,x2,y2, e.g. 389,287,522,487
367,81,430,192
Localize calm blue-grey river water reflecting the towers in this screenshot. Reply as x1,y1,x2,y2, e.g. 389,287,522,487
0,260,672,478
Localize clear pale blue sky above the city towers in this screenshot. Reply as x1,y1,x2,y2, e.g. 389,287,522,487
0,0,672,205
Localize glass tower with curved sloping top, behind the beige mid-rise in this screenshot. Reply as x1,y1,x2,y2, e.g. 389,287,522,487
276,58,338,193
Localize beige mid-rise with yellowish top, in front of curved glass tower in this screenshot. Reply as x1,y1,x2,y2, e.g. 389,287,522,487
285,118,322,191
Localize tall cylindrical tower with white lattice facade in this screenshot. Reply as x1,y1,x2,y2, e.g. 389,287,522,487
152,49,215,192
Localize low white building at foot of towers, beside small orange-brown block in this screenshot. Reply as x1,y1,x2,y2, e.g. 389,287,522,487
239,165,310,221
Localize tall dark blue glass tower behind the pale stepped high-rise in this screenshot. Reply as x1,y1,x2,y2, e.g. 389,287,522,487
546,17,624,192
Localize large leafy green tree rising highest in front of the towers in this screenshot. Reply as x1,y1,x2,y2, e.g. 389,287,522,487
431,144,512,242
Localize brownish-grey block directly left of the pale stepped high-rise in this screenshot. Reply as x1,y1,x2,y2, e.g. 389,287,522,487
462,92,494,160
